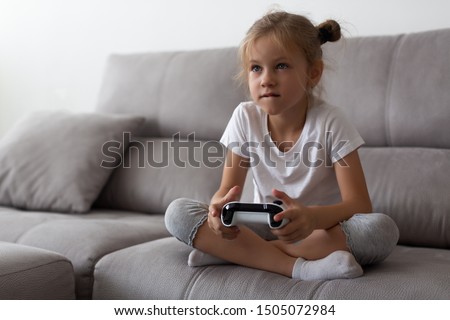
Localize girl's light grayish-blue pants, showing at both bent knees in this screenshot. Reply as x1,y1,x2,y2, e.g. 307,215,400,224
165,198,399,265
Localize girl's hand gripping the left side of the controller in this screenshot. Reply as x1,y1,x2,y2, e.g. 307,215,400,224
208,186,241,240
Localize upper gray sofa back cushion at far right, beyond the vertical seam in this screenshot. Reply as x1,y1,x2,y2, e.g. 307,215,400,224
387,29,450,149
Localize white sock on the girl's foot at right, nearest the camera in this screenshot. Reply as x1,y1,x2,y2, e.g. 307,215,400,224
292,251,363,280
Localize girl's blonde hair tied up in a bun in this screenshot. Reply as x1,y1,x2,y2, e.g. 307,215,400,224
238,11,341,82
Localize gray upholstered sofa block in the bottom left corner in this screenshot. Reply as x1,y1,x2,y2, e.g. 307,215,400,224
0,242,75,300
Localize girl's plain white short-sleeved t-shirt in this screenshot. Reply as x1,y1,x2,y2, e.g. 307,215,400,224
220,99,364,205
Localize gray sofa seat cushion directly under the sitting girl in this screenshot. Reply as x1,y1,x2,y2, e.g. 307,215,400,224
93,238,450,300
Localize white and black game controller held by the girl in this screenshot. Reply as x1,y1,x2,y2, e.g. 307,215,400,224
220,201,289,229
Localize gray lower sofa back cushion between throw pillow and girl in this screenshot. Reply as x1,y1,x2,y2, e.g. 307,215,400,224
95,136,225,214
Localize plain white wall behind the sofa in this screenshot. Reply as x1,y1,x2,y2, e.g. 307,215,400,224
0,0,450,137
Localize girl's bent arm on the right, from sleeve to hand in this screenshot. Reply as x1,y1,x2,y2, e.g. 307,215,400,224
274,150,372,241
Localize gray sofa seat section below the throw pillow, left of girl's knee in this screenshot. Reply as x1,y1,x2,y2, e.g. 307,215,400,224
0,207,168,299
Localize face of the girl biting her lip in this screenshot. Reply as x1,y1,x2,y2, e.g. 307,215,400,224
248,37,311,115
